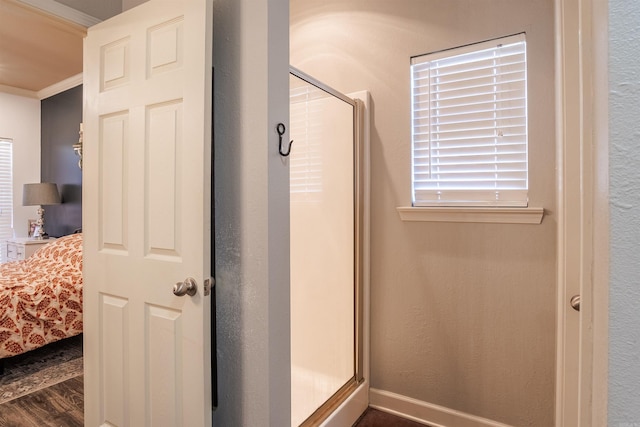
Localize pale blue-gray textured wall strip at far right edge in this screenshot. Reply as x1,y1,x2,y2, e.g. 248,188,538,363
609,0,640,427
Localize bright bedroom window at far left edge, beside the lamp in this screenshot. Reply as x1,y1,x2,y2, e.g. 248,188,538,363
0,138,13,262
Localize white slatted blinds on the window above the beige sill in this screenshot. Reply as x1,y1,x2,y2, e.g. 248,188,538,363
411,34,528,206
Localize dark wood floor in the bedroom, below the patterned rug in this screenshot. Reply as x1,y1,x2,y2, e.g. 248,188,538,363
0,375,84,427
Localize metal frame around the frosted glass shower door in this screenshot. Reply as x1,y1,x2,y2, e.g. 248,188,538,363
289,66,366,427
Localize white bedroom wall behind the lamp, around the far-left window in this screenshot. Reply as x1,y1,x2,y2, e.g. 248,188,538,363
0,92,40,237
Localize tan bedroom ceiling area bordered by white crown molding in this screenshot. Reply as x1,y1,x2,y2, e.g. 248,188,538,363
0,0,86,93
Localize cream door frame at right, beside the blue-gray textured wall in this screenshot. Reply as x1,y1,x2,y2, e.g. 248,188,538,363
555,0,609,427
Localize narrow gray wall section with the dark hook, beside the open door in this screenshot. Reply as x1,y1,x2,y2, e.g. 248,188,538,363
213,0,291,427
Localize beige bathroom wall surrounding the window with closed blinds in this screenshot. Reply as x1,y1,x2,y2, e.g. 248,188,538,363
290,0,556,426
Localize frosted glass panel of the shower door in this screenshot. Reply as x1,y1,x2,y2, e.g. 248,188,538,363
289,75,356,426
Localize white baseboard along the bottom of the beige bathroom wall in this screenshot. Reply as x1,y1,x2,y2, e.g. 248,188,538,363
369,388,510,427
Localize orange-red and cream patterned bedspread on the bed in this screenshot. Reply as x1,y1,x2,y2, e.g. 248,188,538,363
0,234,82,359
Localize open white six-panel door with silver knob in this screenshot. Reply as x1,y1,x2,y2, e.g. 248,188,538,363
83,0,212,427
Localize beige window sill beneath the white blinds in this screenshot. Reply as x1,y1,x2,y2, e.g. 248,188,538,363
396,207,544,224
